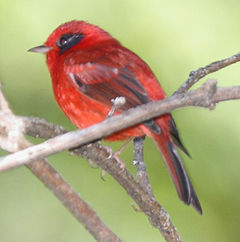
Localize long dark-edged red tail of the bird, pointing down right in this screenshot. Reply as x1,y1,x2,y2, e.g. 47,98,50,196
153,134,202,214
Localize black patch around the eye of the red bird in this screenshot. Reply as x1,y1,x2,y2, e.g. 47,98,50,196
56,33,84,54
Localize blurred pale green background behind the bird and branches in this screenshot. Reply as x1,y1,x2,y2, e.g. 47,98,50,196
0,0,240,242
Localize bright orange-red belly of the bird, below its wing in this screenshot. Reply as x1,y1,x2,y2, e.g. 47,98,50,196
55,84,144,141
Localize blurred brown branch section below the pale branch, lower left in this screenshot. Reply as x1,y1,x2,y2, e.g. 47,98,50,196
26,159,121,242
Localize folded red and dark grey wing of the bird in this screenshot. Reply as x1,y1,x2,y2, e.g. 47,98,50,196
65,59,160,133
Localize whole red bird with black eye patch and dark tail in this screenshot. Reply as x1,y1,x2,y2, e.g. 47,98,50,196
29,21,202,214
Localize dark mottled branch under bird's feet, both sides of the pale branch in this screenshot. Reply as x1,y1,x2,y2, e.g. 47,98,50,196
22,117,181,242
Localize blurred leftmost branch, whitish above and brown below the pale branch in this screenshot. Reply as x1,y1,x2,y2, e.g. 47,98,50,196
0,86,121,242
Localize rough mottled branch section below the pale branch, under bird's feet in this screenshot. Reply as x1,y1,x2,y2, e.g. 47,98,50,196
74,143,181,242
